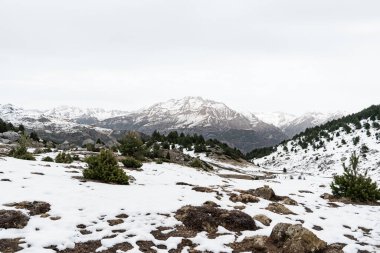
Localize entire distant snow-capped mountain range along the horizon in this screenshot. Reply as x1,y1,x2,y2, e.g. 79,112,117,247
0,97,343,152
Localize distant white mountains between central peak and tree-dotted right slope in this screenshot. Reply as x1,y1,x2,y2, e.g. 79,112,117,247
254,112,347,138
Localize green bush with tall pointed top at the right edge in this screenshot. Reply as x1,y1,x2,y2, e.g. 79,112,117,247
330,152,380,202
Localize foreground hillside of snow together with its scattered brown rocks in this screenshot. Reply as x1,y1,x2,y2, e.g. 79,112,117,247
0,148,380,253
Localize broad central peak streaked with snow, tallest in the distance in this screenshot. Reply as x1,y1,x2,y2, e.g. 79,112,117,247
97,97,286,152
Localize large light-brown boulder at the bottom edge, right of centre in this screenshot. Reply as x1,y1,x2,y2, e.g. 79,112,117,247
269,223,327,253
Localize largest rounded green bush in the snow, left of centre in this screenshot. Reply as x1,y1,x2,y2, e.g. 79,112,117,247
83,150,129,185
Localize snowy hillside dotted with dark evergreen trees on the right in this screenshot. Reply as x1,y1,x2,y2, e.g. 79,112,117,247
254,106,380,181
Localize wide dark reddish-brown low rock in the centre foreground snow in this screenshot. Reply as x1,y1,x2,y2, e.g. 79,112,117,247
175,206,257,233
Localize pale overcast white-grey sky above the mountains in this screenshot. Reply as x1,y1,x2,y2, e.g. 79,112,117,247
0,0,380,114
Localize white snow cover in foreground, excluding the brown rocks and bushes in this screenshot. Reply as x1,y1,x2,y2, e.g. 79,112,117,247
0,157,380,253
